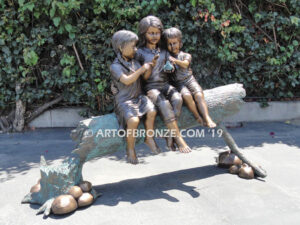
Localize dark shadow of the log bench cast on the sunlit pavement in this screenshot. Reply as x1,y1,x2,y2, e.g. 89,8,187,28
93,165,227,206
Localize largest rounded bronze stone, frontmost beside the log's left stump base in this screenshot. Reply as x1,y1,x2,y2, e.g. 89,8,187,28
51,195,77,214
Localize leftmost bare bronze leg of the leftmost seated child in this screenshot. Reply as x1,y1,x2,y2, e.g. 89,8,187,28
126,117,140,164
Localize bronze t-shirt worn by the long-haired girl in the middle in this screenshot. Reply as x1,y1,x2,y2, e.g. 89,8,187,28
135,47,169,91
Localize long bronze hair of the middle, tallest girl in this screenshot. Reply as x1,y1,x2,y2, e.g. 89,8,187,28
138,16,164,47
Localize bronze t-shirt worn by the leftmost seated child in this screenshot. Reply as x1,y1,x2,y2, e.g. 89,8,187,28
110,58,142,102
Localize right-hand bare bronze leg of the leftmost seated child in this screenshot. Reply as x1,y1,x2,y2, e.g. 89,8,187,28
145,111,160,154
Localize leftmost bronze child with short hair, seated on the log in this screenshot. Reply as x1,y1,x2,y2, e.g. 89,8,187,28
110,30,160,164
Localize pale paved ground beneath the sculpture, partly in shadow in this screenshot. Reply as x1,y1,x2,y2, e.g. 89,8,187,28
0,122,300,225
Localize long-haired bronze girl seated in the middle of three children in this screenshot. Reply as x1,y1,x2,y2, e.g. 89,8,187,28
136,16,191,153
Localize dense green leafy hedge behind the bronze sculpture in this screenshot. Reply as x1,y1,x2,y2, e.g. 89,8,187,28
0,0,300,114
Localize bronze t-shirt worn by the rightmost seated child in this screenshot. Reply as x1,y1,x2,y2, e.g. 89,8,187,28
174,51,193,82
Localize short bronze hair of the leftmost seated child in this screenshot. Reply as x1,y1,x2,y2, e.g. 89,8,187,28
111,30,139,54
